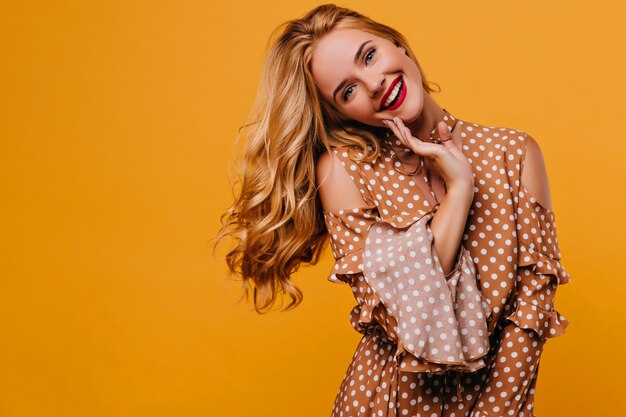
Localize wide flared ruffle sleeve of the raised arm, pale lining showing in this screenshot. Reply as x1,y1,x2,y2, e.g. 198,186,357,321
325,207,491,373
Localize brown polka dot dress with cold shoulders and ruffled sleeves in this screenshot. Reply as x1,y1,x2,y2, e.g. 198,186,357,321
324,109,571,417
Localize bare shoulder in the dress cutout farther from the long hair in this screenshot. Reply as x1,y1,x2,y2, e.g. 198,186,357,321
520,134,552,210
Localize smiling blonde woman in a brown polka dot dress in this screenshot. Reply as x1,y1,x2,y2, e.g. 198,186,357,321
218,4,570,417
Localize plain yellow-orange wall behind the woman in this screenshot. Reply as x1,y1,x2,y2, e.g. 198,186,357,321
0,0,626,417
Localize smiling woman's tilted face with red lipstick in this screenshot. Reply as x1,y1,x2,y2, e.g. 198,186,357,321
311,29,425,127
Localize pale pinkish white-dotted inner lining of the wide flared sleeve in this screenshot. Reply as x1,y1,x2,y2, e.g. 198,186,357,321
363,213,489,372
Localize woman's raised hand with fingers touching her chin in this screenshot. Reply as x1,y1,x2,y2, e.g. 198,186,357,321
384,117,474,192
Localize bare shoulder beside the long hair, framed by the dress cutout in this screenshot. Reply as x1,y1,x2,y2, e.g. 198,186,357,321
315,151,370,212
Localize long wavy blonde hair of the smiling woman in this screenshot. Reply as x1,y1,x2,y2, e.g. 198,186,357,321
214,4,440,313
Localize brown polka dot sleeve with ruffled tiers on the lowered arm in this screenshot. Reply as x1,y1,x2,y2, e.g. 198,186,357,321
507,185,571,339
